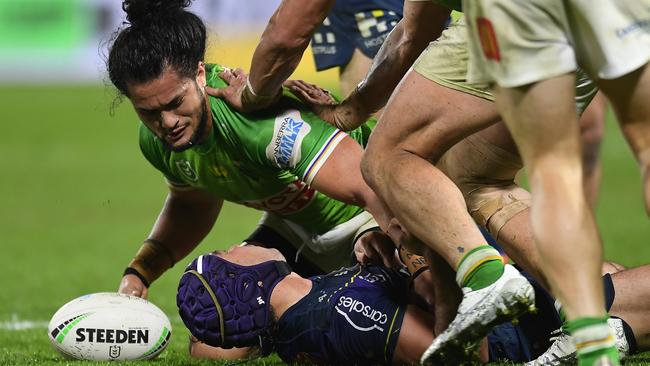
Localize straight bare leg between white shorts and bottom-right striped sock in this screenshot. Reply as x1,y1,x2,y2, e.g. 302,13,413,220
495,74,604,319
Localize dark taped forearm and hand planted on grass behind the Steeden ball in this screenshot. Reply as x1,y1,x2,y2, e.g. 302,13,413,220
118,187,223,297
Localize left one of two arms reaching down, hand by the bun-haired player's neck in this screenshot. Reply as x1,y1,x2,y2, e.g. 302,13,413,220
208,0,335,112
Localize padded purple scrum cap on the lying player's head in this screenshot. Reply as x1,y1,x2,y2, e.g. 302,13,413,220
176,255,291,348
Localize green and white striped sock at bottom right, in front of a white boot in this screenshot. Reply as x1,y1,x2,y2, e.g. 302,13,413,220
566,316,621,366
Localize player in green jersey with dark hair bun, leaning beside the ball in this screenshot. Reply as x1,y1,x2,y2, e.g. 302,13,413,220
108,0,400,302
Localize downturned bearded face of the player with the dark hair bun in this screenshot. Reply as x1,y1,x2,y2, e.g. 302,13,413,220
128,64,211,151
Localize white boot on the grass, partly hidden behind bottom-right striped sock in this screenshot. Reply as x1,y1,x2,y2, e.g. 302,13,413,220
526,318,630,366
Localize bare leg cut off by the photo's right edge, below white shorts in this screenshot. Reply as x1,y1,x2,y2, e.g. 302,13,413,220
598,64,650,215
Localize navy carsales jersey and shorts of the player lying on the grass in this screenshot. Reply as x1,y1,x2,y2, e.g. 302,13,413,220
272,265,614,365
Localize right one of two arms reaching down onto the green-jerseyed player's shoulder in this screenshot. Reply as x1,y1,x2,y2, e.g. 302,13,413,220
292,1,451,131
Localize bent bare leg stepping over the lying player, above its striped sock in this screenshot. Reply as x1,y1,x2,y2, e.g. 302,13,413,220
362,71,498,268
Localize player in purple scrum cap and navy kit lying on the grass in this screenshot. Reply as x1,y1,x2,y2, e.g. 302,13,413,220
177,246,650,364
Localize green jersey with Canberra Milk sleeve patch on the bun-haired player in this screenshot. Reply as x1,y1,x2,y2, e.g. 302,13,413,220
140,65,374,234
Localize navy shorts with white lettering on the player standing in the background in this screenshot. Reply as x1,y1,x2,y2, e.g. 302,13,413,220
311,0,404,71
